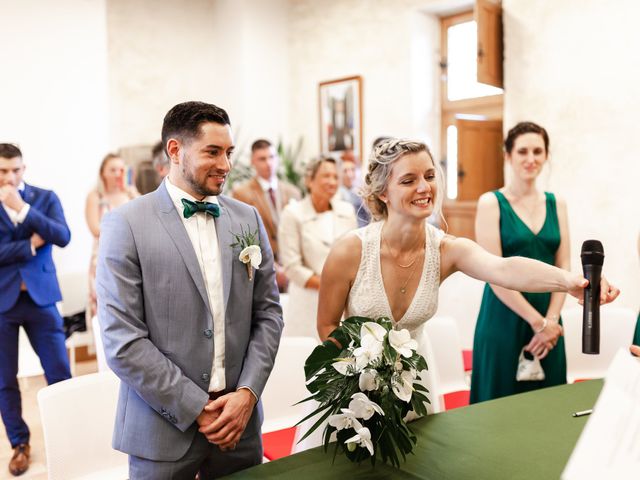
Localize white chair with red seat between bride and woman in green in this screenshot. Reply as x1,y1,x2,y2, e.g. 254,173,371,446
418,316,469,413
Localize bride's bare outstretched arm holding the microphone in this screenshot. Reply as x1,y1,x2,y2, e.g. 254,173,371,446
441,237,620,304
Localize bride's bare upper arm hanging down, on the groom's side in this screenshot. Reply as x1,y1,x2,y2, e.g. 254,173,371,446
318,233,362,341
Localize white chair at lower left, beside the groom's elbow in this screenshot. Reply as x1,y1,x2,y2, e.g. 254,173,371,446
38,372,128,480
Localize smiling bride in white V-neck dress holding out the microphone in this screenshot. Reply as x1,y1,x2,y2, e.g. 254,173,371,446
317,139,619,357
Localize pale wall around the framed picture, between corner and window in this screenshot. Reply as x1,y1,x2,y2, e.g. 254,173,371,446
289,0,439,164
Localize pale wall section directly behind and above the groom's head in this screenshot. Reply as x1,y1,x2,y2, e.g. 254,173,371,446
107,0,289,158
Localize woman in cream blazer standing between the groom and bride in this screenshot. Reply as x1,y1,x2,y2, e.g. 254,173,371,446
278,157,357,338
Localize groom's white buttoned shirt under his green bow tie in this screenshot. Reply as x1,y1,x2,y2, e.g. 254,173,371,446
165,177,226,392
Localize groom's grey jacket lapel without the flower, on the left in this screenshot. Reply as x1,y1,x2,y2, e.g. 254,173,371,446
155,183,211,311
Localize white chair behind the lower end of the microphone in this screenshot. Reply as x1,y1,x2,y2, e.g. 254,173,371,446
562,305,636,383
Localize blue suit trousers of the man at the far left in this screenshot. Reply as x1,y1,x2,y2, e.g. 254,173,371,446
0,292,71,448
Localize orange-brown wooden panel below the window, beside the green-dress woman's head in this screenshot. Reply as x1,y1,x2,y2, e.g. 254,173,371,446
456,119,504,201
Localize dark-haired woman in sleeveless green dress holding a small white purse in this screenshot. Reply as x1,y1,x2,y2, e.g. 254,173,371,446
470,122,570,403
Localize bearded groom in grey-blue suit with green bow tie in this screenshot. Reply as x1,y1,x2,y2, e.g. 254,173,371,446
96,102,282,480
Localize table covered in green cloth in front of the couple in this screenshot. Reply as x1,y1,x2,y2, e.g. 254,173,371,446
228,380,603,480
